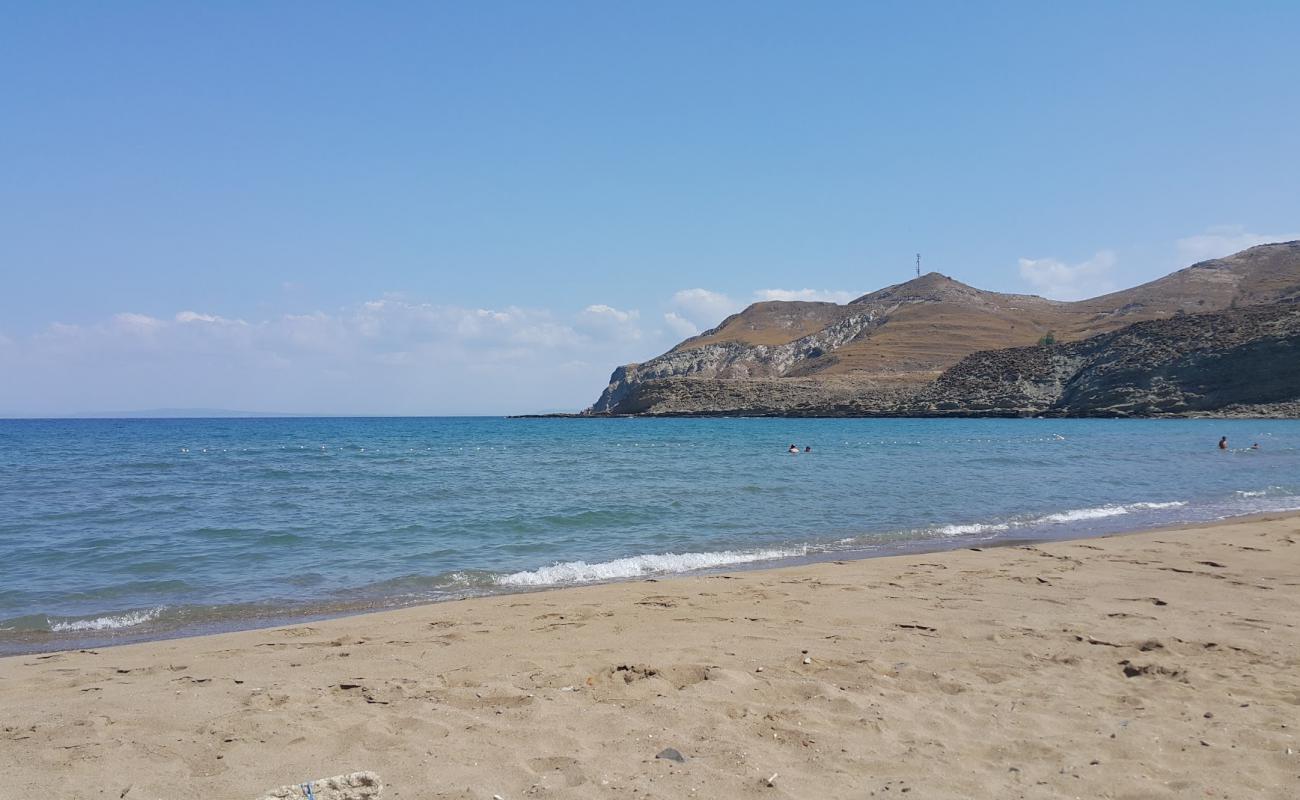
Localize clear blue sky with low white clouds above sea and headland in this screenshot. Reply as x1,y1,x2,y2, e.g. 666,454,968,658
0,0,1300,415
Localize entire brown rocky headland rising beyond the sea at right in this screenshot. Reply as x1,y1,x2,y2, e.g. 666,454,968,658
582,242,1300,416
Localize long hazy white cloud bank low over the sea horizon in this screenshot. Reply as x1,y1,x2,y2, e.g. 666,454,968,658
0,295,676,414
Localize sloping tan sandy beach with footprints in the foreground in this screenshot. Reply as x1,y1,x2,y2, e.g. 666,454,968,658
0,516,1300,800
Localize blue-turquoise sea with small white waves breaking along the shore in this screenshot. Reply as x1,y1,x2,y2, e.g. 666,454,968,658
0,418,1300,653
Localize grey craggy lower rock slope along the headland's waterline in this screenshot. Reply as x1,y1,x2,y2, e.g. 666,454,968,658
587,303,1300,416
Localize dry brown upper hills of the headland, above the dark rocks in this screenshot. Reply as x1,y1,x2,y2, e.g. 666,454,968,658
588,242,1300,414
